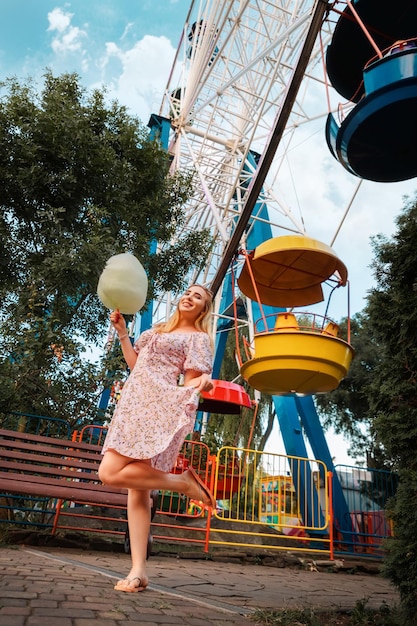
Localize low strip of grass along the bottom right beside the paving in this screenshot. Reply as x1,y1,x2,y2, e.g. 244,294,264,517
250,599,407,626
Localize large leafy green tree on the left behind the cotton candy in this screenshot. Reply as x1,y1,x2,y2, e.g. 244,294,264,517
0,72,209,425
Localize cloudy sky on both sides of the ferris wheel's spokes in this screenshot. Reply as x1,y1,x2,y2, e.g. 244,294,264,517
0,0,417,463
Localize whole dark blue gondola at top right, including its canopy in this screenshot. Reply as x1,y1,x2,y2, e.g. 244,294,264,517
326,0,417,182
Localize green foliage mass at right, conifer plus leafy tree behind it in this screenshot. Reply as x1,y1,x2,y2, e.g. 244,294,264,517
308,190,417,624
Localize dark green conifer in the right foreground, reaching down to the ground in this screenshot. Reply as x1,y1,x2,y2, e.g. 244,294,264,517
367,193,417,624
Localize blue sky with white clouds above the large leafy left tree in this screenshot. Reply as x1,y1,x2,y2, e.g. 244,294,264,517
0,0,189,123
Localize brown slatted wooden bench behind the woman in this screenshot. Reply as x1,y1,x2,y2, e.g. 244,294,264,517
0,429,210,552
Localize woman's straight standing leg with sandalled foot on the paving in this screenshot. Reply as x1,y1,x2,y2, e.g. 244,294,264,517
115,489,151,592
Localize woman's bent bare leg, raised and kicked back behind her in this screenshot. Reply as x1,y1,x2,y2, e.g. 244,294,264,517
98,450,213,505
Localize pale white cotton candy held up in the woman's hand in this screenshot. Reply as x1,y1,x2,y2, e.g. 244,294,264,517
97,253,148,315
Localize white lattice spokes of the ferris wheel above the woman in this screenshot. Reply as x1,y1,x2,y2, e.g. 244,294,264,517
151,0,331,314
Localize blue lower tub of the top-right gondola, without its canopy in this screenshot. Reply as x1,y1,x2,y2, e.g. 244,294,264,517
326,48,417,182
